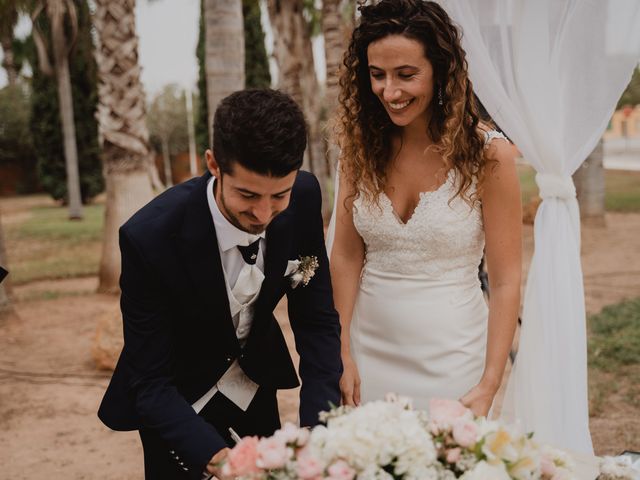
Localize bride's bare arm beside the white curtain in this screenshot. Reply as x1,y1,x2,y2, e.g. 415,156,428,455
462,139,522,415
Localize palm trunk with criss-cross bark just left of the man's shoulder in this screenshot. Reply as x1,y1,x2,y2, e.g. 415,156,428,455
94,0,153,292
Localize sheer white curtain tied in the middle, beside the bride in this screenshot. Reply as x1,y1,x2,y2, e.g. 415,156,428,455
439,0,640,453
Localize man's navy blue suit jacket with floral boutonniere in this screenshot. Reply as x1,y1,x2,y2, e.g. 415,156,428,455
98,172,342,471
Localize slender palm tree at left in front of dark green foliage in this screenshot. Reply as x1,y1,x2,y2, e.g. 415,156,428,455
31,0,83,219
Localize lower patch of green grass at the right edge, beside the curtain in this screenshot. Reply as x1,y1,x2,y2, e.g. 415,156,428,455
588,298,640,372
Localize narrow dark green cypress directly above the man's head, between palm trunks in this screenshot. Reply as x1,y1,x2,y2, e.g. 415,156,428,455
242,0,271,88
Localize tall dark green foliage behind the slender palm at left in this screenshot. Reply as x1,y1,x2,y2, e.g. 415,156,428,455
29,0,104,203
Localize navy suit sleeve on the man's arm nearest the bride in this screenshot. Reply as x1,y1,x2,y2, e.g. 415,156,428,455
287,175,342,426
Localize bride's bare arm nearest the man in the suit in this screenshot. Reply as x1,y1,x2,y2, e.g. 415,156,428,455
329,172,364,405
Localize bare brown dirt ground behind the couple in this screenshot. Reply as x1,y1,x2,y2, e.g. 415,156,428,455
0,215,640,480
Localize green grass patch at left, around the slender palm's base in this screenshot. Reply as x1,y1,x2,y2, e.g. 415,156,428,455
5,205,104,285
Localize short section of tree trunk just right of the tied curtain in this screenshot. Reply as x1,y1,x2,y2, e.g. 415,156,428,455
573,140,605,226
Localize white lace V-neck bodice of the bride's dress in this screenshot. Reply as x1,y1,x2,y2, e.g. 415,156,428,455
353,170,484,280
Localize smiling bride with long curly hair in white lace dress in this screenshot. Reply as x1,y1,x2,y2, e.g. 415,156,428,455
330,0,521,415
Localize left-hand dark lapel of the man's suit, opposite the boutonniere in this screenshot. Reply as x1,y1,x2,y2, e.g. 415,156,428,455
177,174,240,349
